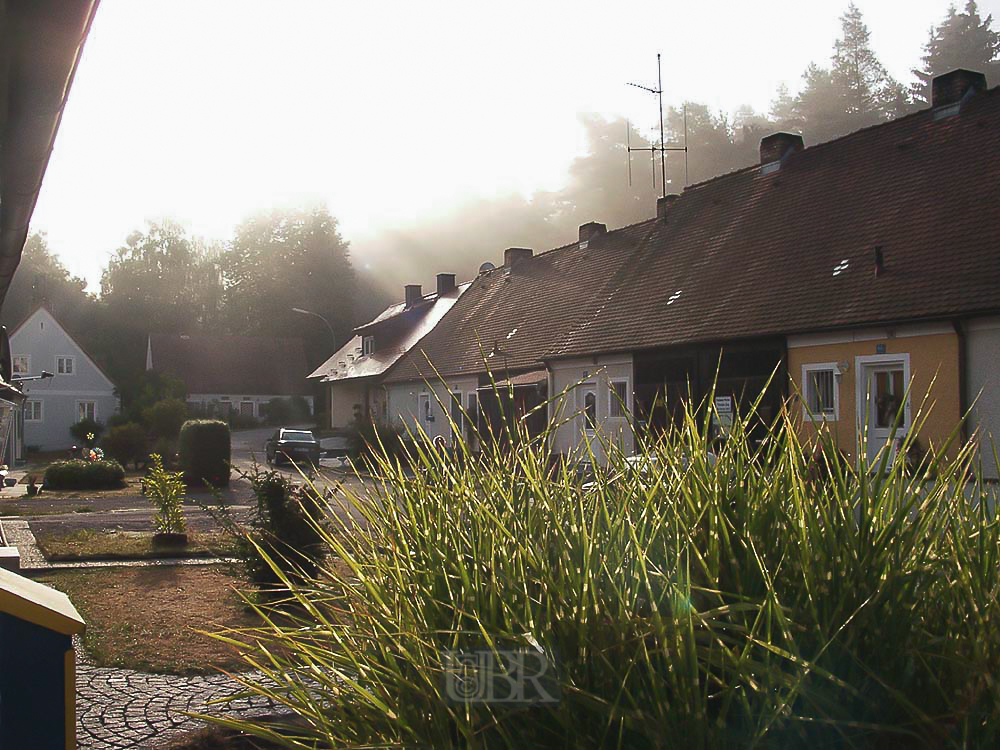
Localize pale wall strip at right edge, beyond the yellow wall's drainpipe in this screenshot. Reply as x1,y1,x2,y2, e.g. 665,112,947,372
965,317,1000,479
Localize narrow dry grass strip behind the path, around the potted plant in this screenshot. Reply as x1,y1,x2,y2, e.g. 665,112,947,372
36,529,233,562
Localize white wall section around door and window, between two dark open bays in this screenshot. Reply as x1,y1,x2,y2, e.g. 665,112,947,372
549,354,635,463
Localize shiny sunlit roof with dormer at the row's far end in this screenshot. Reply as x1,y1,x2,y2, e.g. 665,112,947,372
309,282,471,383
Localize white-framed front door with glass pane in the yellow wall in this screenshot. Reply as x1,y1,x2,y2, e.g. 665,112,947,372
858,355,910,465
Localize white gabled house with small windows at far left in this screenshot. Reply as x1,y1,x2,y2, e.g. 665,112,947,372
10,307,119,460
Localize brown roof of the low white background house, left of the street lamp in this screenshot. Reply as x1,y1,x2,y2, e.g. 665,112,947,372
149,334,311,396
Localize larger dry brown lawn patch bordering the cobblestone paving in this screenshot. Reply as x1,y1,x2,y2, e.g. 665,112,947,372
37,565,258,675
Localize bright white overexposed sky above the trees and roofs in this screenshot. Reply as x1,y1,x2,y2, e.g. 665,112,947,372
32,0,1000,290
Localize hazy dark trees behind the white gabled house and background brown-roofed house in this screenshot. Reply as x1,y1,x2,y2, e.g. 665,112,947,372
3,208,385,403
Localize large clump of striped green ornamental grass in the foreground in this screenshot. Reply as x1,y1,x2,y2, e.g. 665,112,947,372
207,384,1000,748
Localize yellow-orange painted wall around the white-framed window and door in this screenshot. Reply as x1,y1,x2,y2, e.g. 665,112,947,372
788,332,961,458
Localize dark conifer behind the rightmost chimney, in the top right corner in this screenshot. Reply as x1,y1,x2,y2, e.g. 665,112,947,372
912,0,1000,105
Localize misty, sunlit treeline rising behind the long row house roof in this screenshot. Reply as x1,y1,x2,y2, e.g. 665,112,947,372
359,2,1000,286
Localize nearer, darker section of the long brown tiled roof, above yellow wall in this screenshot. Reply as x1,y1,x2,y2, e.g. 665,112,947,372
548,89,1000,356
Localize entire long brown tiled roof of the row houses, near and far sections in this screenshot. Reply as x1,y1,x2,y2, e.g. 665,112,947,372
388,89,1000,380
